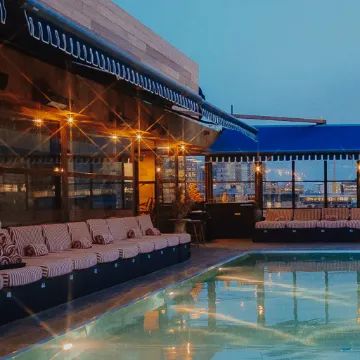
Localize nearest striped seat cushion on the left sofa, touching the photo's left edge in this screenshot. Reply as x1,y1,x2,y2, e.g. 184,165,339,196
0,266,43,288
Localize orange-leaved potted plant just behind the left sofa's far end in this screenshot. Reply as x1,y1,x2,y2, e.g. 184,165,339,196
171,187,194,233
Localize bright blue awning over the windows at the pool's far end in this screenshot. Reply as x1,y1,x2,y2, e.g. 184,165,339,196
210,125,360,161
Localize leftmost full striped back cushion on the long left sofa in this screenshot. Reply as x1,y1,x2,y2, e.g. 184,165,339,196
10,225,45,256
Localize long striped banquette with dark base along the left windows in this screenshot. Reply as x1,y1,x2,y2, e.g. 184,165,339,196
0,215,191,324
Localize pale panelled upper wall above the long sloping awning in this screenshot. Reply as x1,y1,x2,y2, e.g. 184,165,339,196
41,0,199,91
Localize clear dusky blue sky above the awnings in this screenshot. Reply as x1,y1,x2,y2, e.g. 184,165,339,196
115,0,360,123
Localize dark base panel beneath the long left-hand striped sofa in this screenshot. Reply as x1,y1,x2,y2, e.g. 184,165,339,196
0,244,190,325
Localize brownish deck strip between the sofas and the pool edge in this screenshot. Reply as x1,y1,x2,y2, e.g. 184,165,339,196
0,239,360,356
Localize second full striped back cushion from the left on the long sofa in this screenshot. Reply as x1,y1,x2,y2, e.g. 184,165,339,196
42,224,71,252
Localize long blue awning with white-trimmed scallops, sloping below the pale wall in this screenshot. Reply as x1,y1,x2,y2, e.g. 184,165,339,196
17,0,257,137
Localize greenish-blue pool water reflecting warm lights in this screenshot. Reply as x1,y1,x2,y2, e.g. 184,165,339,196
9,253,360,360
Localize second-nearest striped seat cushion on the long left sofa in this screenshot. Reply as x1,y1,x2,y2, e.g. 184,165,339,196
24,255,74,278
